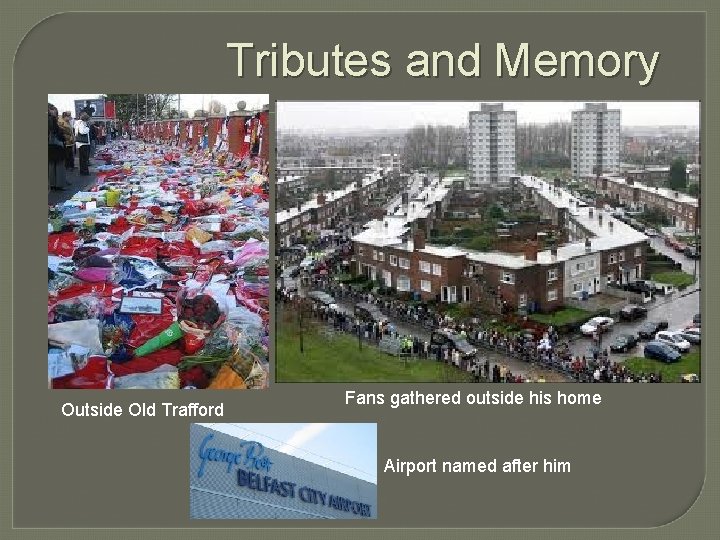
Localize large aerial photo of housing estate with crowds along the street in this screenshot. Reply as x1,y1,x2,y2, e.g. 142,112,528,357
275,102,701,383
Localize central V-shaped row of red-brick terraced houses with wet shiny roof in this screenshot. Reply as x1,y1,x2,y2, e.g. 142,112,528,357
353,177,648,312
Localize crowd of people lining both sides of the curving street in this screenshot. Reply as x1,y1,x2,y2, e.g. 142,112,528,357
278,266,662,383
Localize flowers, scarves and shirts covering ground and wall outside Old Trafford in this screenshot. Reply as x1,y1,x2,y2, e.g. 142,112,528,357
48,94,270,389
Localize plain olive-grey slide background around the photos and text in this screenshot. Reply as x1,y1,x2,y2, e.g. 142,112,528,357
0,0,720,539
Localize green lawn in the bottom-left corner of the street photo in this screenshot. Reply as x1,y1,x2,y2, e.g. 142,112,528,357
275,318,472,383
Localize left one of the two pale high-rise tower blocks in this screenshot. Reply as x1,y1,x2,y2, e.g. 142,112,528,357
467,103,517,187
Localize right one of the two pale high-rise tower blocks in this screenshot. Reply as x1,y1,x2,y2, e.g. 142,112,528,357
570,103,620,178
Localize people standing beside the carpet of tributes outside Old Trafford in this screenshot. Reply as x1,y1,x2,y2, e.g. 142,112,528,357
48,103,120,191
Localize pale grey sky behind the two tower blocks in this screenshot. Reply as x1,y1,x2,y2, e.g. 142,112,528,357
277,101,700,130
